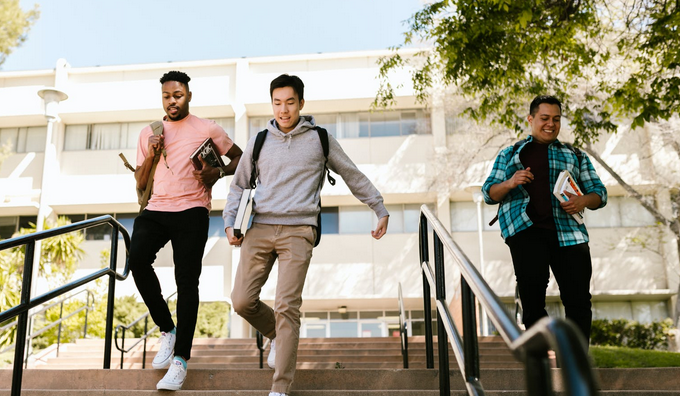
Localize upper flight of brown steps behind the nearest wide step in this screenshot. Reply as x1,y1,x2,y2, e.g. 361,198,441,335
21,337,522,370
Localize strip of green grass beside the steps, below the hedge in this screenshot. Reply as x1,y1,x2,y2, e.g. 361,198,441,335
590,345,680,368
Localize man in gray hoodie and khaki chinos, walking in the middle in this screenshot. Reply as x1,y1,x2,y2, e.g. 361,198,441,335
223,74,389,396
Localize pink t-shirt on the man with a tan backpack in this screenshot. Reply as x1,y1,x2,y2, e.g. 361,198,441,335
137,114,234,212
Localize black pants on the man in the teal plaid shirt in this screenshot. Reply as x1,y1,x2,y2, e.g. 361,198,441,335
506,227,593,341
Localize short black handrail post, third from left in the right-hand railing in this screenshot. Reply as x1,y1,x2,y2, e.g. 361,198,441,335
460,276,480,380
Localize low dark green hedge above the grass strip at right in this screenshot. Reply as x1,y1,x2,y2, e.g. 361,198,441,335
590,319,673,350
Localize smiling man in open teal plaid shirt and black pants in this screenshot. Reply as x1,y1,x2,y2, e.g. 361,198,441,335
482,96,607,340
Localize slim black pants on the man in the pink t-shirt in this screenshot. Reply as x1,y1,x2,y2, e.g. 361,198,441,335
130,208,209,360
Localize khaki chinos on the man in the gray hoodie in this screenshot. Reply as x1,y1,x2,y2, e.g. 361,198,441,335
231,223,316,394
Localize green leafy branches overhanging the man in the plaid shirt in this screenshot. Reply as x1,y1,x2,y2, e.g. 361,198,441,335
374,0,680,145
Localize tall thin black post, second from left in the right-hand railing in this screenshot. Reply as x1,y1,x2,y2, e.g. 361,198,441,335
432,233,451,396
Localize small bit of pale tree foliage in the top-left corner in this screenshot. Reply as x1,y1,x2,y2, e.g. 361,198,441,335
0,0,40,65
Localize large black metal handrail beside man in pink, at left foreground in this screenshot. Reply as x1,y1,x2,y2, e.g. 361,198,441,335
0,215,130,396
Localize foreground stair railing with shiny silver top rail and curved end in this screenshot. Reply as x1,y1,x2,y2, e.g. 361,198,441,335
419,205,597,396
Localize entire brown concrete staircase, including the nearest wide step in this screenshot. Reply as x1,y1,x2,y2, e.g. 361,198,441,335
0,337,680,396
